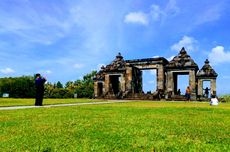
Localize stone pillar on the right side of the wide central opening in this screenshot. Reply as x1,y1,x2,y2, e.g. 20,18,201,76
156,65,165,90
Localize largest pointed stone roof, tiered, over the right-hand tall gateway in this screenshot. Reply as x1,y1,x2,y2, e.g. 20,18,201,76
166,47,198,69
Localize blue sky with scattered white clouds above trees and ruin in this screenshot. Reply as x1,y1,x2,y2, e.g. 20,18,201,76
0,0,230,94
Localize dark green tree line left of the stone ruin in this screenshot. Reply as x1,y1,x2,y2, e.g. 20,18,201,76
0,71,96,98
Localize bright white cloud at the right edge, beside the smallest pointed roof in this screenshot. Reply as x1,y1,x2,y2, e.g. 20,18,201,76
208,46,230,64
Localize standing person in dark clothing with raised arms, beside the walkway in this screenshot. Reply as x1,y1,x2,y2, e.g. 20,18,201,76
35,73,46,106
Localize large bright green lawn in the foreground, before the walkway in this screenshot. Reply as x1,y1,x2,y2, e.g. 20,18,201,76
0,101,230,152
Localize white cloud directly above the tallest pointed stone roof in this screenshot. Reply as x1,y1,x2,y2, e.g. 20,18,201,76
171,36,198,52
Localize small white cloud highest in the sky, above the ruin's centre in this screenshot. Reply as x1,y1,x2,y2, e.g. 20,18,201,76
124,12,149,25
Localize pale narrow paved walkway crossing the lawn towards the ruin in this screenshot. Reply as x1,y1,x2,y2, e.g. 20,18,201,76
0,100,136,110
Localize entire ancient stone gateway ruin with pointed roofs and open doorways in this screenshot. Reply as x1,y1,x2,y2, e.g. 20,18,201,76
94,48,217,100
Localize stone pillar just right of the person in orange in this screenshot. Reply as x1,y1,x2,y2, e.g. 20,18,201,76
189,70,196,100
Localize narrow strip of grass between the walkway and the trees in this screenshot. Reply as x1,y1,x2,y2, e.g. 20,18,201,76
0,98,105,107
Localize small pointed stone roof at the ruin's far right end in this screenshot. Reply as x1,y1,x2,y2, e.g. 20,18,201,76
197,59,218,78
